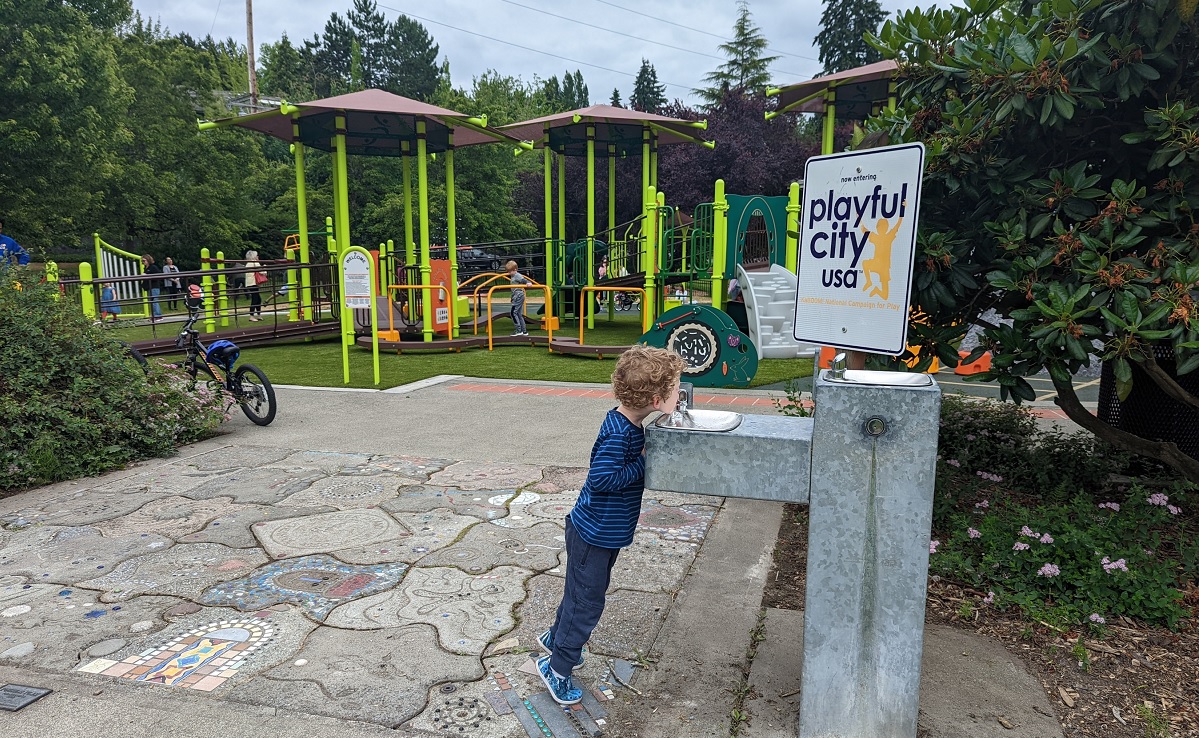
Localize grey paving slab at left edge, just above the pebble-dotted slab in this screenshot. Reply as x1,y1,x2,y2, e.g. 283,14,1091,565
0,526,174,585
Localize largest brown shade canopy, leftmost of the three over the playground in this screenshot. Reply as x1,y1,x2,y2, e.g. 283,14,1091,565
208,90,518,156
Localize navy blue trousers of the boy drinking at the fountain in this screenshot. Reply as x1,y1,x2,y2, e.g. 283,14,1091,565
549,515,620,677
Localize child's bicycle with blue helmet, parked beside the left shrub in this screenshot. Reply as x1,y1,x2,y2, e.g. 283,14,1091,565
175,304,277,425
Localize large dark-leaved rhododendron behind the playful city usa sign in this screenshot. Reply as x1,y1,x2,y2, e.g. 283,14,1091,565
870,0,1199,482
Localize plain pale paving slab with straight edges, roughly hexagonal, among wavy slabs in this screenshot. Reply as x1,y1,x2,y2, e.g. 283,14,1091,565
251,508,411,558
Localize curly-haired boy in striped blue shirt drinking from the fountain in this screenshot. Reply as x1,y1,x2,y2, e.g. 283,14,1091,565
537,345,685,704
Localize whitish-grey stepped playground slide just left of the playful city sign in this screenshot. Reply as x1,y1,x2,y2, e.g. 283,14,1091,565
737,264,819,359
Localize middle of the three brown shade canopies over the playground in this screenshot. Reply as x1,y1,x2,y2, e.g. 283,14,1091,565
500,105,700,156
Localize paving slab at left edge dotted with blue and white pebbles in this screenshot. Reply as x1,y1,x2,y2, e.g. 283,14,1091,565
0,585,181,670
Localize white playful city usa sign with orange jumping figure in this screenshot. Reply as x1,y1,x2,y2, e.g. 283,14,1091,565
795,144,924,355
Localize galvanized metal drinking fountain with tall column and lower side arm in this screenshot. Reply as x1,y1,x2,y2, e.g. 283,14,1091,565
645,370,941,738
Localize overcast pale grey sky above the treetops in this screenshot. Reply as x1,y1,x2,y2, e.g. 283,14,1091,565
133,0,933,103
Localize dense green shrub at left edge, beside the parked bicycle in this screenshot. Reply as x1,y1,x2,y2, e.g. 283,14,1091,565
0,267,224,491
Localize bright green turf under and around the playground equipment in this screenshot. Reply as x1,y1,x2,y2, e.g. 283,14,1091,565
215,314,812,388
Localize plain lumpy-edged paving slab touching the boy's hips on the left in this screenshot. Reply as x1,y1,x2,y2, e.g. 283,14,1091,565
421,522,566,574
